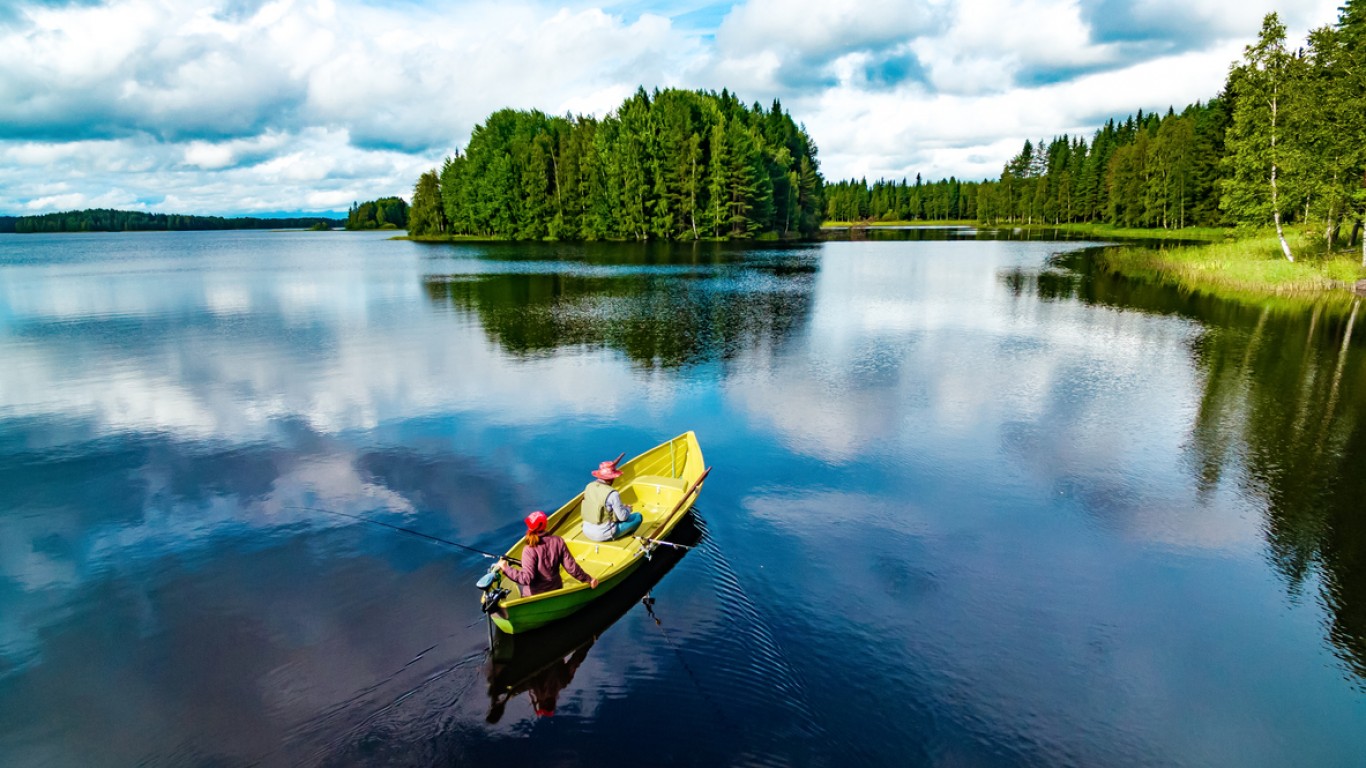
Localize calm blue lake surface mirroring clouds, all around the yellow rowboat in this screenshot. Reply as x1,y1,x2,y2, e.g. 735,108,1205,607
0,230,1366,767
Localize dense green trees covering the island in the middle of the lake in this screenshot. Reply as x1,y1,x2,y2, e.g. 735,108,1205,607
408,89,824,241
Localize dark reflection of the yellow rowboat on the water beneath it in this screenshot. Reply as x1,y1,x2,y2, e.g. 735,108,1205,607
486,510,702,723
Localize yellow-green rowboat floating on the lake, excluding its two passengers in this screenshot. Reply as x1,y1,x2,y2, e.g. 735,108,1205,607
479,432,710,634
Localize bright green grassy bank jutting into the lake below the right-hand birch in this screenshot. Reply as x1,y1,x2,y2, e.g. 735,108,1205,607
1097,234,1366,299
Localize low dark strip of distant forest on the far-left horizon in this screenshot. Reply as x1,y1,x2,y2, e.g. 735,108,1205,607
0,208,342,234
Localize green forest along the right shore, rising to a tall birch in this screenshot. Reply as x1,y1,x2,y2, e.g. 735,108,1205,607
826,0,1366,256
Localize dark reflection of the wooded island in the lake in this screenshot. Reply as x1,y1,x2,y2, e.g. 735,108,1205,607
423,243,817,369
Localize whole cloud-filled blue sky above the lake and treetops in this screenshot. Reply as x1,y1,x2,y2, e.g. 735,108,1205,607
0,0,1337,215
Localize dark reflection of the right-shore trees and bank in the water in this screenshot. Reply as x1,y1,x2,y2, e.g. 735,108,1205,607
1000,251,1366,679
